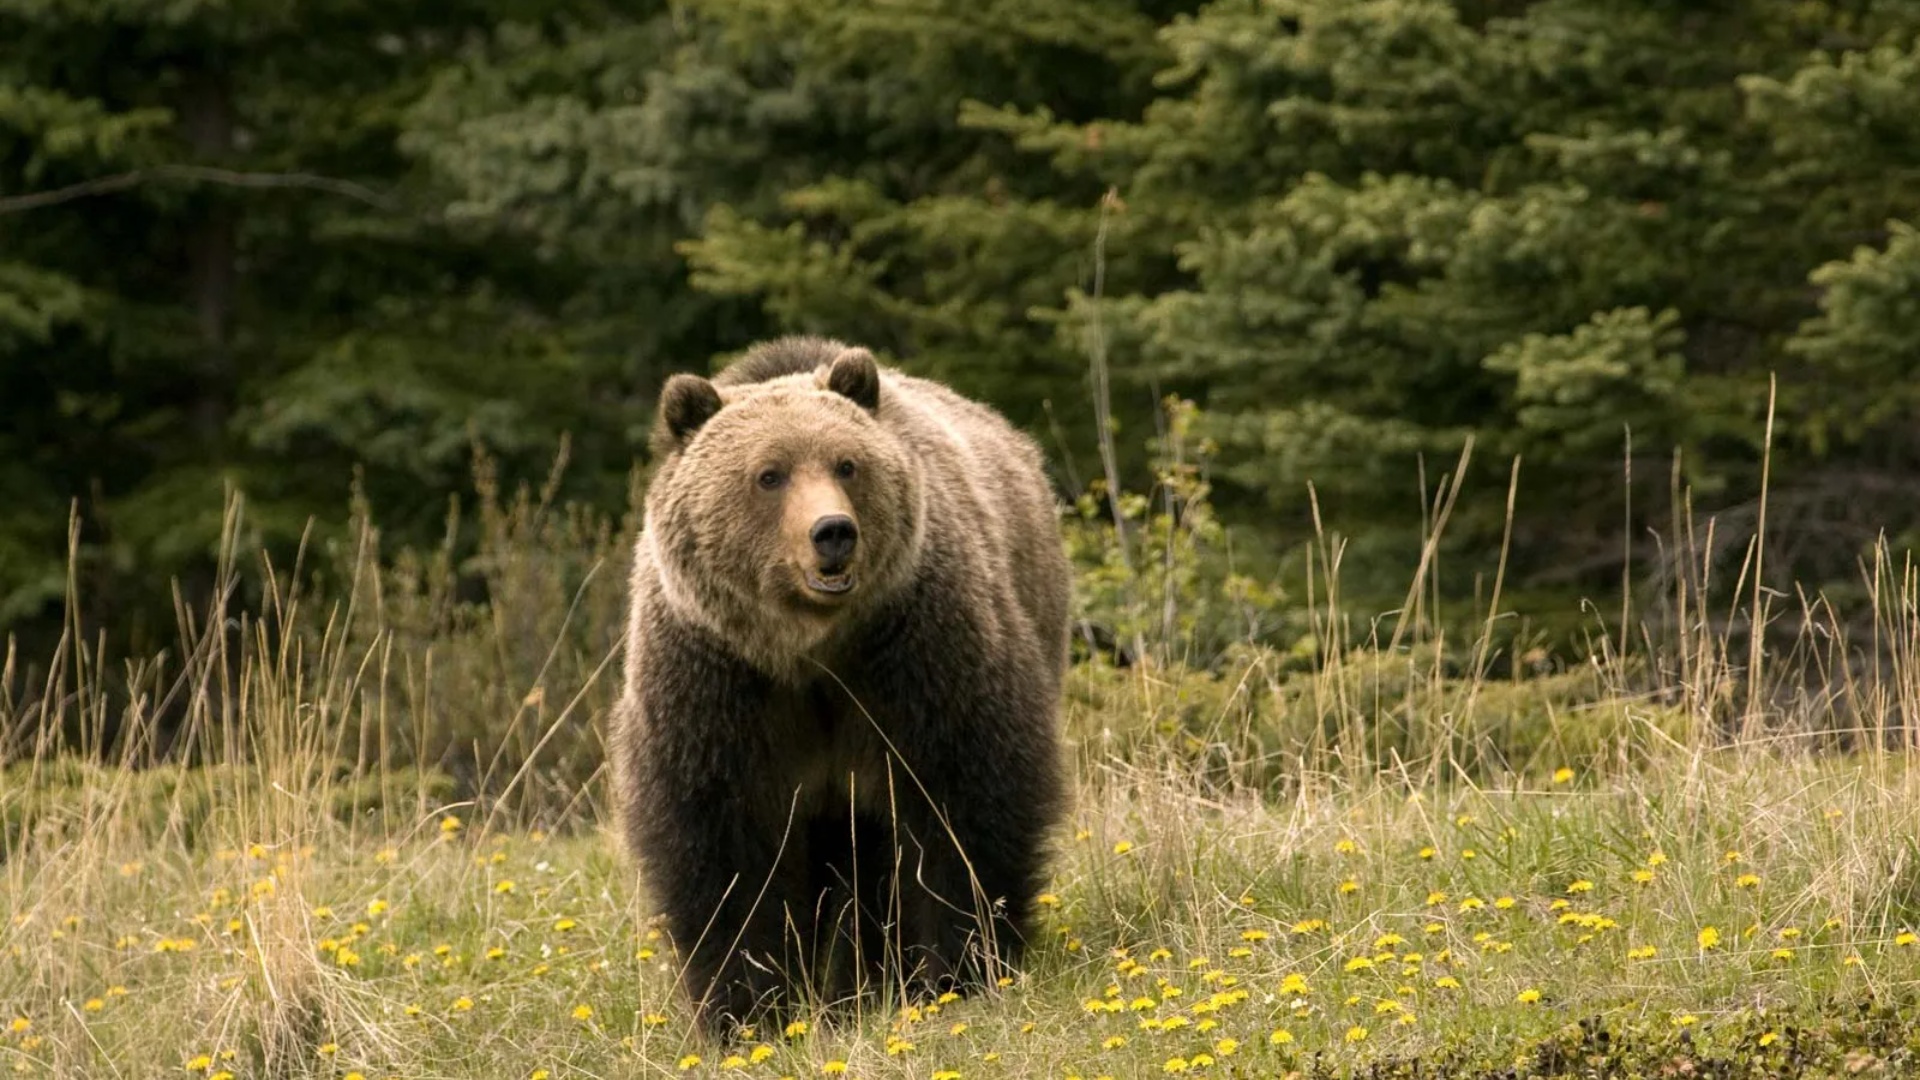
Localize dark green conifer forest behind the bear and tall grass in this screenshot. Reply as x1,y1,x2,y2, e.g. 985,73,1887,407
0,0,1920,655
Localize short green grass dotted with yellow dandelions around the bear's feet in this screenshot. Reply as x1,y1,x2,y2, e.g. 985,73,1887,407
11,737,1920,1078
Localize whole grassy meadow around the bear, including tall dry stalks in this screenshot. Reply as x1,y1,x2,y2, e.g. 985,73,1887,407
0,455,1920,1080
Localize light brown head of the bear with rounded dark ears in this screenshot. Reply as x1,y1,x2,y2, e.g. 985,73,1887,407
645,348,924,673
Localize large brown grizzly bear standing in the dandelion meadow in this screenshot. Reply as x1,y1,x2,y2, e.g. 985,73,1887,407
611,338,1071,1036
